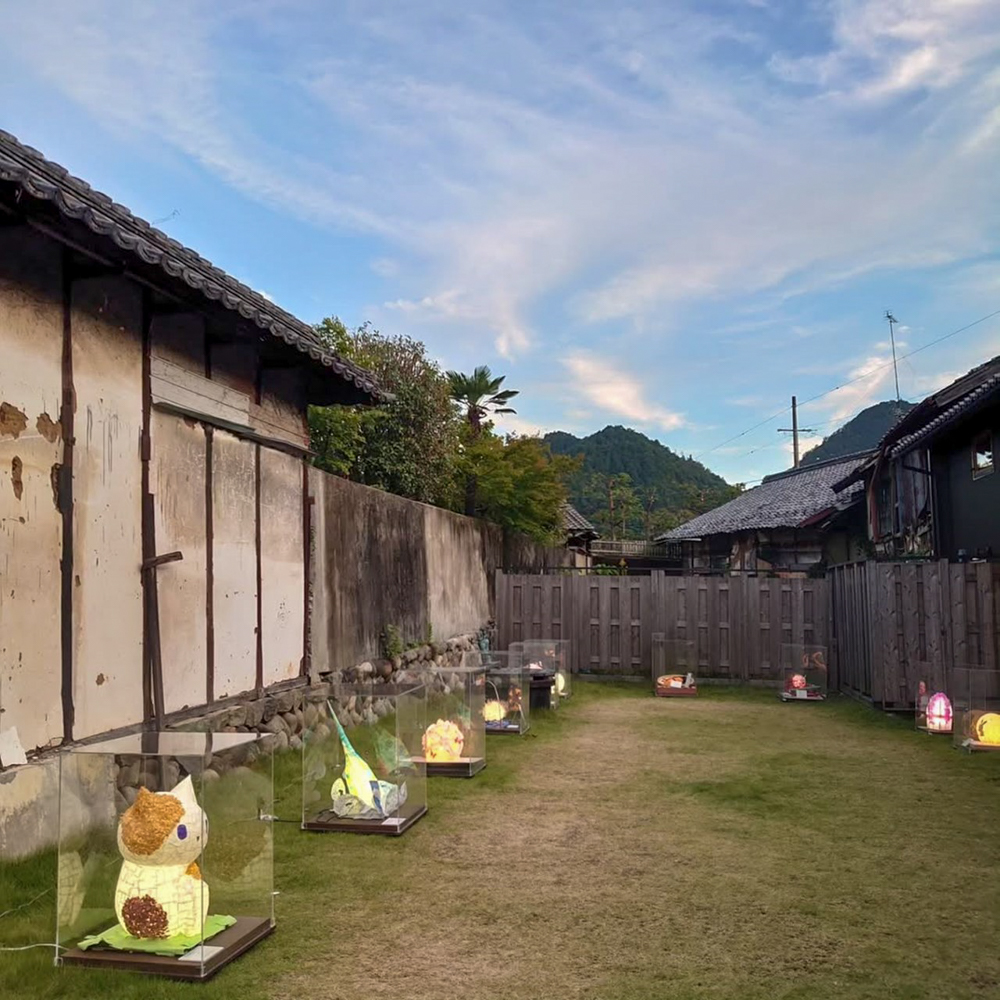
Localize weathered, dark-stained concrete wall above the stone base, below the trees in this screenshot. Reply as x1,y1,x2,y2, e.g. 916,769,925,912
309,468,577,674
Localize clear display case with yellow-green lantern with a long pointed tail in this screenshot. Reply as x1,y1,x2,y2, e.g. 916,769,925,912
302,683,427,836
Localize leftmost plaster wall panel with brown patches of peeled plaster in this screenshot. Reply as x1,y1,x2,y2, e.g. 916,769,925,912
0,228,62,749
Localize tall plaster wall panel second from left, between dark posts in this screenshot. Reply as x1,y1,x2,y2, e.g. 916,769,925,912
72,277,143,736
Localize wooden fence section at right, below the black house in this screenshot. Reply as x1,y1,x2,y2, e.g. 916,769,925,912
828,561,1000,709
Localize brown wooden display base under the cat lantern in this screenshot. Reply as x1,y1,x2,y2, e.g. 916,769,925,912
60,917,274,982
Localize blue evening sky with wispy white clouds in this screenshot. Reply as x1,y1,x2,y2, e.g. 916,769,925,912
0,0,1000,482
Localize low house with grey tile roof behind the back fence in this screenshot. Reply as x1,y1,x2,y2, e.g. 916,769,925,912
656,452,870,576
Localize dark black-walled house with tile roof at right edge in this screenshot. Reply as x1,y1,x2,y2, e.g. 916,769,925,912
843,356,1000,562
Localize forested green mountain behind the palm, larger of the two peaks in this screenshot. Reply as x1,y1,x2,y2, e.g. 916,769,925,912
544,425,733,537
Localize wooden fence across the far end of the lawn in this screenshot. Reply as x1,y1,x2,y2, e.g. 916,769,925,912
497,571,836,686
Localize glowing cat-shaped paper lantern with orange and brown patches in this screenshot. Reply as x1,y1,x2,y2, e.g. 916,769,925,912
115,776,208,938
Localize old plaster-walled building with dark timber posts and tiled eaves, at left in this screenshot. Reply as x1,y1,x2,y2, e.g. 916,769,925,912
0,132,381,751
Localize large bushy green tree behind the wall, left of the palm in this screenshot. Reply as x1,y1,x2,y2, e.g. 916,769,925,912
309,316,459,503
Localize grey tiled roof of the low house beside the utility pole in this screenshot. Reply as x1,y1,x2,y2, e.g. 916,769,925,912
657,453,868,541
